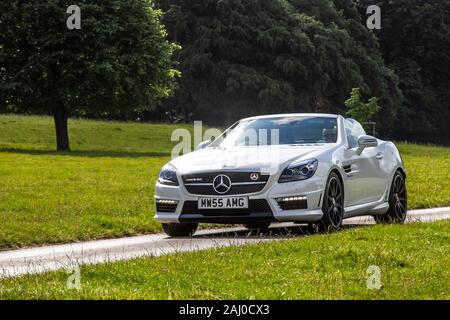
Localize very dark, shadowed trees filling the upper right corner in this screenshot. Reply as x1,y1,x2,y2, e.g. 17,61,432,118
359,0,450,144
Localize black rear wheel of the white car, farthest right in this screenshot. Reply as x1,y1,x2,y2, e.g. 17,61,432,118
374,171,408,223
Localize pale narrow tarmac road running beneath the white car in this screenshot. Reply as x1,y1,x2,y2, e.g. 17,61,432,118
0,207,450,278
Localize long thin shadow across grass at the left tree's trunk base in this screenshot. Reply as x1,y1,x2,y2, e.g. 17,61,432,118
0,148,170,158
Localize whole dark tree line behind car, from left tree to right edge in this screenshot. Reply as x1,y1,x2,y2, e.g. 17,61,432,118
156,0,450,144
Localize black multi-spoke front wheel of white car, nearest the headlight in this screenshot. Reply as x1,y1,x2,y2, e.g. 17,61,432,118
309,172,344,232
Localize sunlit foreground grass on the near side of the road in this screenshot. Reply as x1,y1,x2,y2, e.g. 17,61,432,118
0,221,450,299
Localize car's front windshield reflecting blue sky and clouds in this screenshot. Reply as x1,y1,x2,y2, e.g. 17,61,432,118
220,116,337,147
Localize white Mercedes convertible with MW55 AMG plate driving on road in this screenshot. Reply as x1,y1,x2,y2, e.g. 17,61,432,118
155,114,407,236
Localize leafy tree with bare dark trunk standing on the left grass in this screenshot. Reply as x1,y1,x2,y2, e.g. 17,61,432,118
0,0,177,150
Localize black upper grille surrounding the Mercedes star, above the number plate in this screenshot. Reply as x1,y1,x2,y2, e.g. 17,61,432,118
183,171,270,195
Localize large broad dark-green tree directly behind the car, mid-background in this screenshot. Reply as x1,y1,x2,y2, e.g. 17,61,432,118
156,0,402,136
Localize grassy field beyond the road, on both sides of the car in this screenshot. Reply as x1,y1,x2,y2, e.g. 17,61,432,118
0,115,450,249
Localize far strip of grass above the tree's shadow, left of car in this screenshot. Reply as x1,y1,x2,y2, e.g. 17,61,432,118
0,115,192,157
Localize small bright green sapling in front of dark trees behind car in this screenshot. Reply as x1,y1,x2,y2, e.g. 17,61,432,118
345,88,381,123
